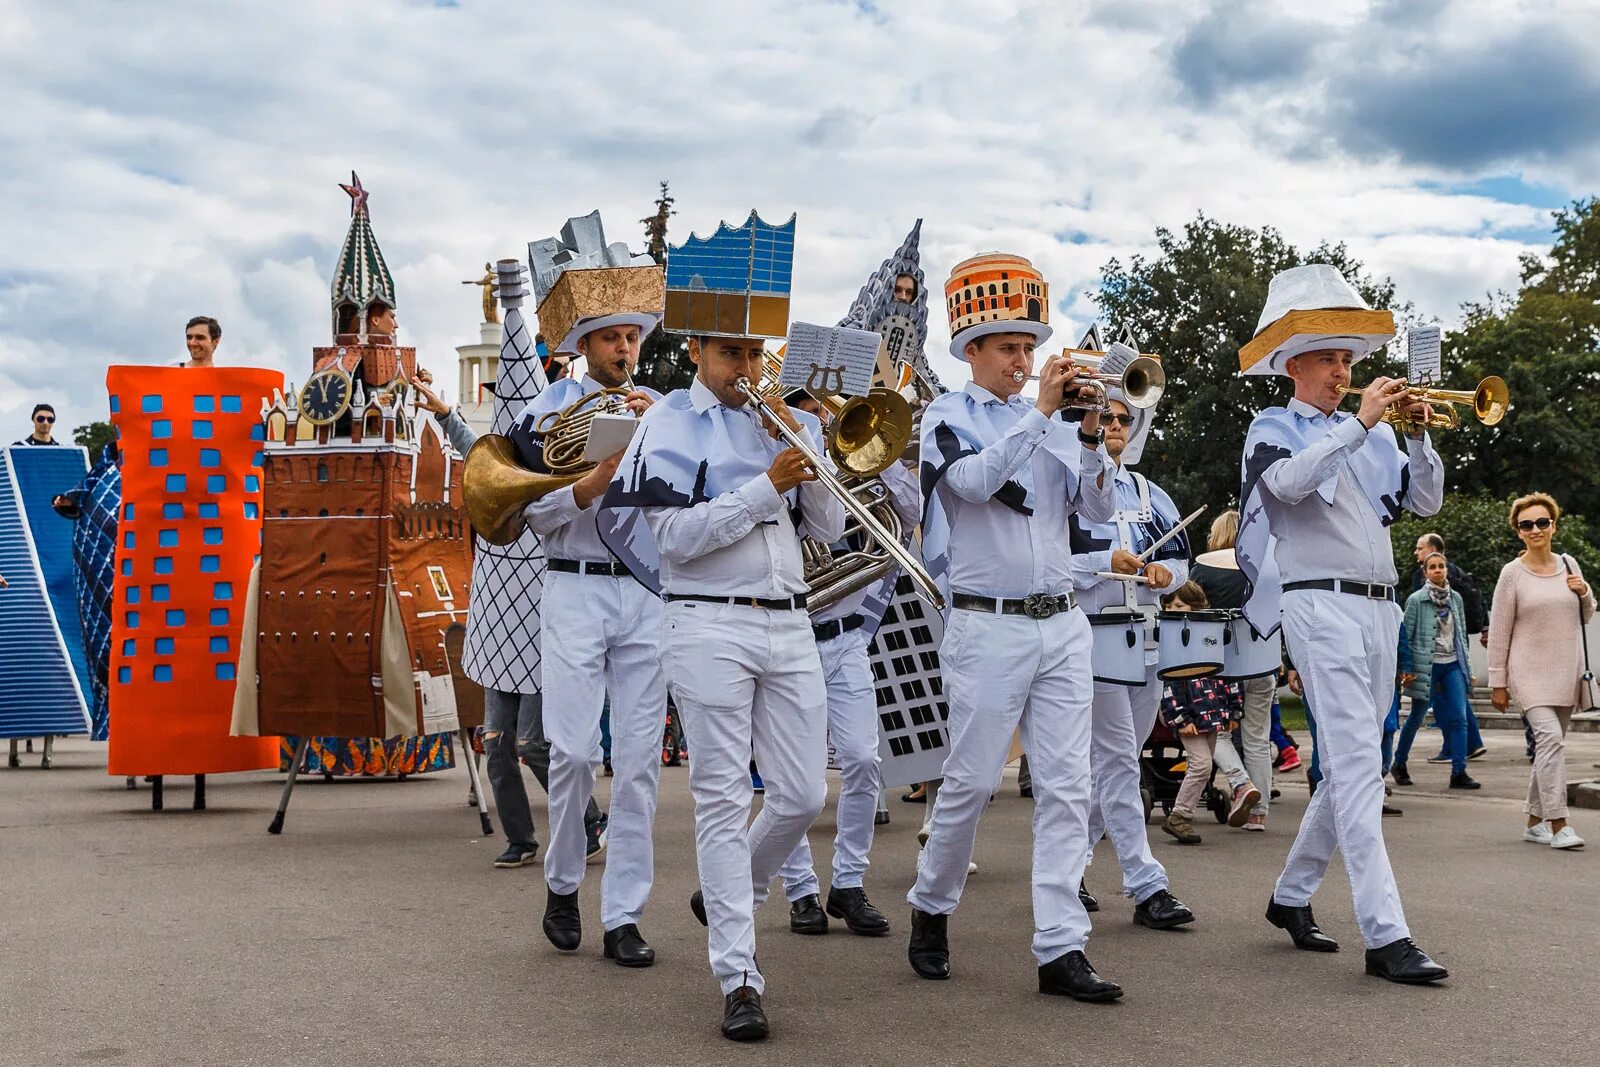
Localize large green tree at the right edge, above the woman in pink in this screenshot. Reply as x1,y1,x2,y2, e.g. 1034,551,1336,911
1435,198,1600,531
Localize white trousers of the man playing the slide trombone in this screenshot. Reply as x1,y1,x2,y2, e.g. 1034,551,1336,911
661,600,832,993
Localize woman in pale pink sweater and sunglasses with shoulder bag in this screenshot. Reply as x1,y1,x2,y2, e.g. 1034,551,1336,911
1490,493,1595,848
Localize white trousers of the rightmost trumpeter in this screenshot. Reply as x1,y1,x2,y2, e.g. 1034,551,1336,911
1272,589,1411,949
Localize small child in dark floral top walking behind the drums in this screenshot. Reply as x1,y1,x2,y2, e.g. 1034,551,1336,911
1162,582,1261,845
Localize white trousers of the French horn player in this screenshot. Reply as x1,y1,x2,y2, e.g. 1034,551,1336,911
539,571,667,929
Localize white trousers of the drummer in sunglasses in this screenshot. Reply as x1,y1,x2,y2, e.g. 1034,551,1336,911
1090,664,1166,902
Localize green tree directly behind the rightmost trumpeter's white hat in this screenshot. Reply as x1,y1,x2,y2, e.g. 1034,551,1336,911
1093,214,1410,515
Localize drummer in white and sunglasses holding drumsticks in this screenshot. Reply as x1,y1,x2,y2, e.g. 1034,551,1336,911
1069,383,1203,929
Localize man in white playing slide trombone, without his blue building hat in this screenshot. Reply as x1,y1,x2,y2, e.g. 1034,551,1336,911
606,334,851,1041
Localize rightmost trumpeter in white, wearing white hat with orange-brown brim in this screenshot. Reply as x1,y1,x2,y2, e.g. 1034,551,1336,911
1237,264,1446,984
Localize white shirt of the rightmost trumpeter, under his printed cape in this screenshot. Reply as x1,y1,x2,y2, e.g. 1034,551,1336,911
1261,400,1445,585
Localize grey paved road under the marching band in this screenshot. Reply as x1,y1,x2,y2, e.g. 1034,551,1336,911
0,734,1600,1067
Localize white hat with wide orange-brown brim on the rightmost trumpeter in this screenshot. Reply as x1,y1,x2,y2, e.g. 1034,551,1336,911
1238,262,1395,374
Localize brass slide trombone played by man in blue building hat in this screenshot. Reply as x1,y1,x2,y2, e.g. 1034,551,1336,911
733,378,944,611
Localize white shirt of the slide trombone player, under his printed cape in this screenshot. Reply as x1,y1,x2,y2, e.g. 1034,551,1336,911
645,378,845,600
